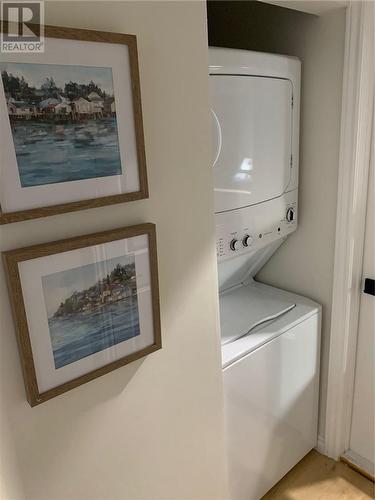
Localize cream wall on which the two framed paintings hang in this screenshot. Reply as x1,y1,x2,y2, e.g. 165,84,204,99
0,2,229,500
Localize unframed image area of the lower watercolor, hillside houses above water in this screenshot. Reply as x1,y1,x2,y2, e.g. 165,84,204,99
42,255,140,369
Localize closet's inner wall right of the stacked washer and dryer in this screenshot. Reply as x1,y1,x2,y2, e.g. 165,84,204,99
257,8,345,437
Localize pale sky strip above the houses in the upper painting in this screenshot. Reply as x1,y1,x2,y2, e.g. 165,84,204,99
0,62,114,96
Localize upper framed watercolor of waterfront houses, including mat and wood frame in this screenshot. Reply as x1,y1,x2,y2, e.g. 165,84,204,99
0,26,148,224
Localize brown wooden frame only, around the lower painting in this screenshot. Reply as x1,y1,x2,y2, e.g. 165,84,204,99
3,223,162,406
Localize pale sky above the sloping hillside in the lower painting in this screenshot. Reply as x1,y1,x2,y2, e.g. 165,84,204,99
42,254,134,317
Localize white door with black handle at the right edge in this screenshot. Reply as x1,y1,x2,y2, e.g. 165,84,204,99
346,134,375,475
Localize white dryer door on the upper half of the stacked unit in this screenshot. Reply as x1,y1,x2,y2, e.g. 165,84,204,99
210,75,293,213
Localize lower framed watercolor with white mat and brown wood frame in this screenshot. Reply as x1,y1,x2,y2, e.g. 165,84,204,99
3,224,161,406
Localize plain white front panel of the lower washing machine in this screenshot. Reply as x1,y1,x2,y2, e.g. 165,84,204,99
223,314,320,500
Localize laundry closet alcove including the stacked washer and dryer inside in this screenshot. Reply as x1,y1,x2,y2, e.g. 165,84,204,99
208,2,345,499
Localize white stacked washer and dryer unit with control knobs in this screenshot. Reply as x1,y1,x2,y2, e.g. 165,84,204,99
209,48,321,500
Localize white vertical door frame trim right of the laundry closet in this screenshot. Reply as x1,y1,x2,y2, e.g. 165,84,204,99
323,1,375,460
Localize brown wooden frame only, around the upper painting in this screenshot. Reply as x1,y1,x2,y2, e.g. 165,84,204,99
0,24,148,224
